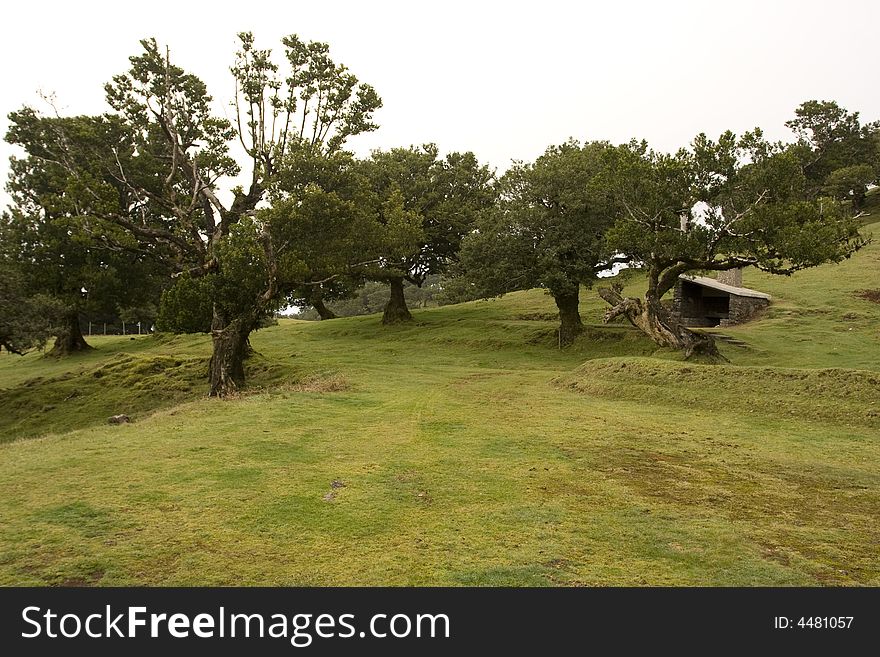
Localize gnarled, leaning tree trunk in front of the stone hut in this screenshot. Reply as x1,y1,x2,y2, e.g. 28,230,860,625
599,284,727,360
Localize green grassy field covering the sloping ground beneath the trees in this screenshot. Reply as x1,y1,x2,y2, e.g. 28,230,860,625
0,224,880,586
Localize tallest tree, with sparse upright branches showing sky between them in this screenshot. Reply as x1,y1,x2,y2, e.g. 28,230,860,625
4,33,381,396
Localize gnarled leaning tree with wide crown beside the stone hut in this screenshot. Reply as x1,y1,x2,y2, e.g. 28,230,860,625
599,131,865,356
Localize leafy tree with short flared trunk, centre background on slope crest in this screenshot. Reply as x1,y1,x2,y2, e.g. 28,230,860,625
365,144,494,324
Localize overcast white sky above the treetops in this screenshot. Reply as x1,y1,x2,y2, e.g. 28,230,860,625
0,0,880,205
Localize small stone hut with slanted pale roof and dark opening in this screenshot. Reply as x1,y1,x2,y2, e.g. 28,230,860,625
672,269,770,327
